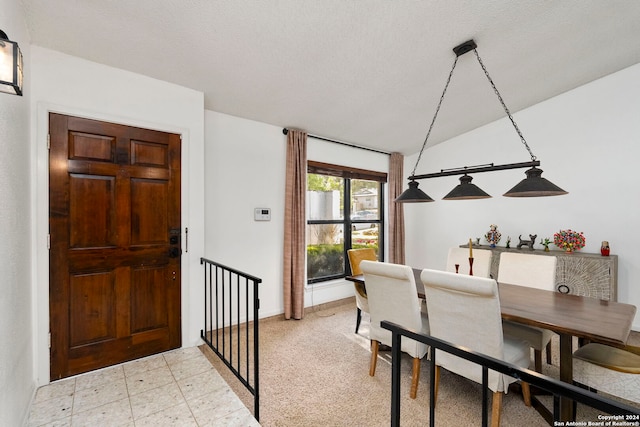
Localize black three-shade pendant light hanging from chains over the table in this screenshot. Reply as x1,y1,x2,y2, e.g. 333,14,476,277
395,40,567,203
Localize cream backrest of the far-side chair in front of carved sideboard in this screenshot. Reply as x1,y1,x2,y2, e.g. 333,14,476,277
498,252,557,291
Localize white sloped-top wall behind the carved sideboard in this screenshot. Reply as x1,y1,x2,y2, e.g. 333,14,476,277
405,64,640,330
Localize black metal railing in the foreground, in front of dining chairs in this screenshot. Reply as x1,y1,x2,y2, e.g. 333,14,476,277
380,320,640,427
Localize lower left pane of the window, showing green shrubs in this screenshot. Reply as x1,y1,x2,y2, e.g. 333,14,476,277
307,224,345,280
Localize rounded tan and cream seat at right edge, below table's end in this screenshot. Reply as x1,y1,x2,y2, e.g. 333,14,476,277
573,343,640,403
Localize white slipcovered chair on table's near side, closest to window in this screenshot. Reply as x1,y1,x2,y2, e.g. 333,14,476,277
360,260,429,399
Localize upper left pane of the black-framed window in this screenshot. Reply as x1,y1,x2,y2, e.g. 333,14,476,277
307,173,344,220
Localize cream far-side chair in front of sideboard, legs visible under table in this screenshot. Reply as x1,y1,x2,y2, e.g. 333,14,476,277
498,252,557,372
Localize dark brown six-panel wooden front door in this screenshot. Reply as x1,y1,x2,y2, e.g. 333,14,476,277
49,113,181,380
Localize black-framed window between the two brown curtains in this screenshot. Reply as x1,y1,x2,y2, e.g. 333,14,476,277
307,162,387,283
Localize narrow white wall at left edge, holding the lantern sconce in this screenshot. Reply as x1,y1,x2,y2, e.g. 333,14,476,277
0,0,35,426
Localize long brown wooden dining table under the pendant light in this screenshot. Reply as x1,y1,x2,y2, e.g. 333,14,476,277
346,268,636,424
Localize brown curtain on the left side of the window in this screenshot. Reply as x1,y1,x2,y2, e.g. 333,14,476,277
283,129,307,319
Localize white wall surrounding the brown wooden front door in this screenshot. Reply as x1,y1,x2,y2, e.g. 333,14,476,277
30,46,204,384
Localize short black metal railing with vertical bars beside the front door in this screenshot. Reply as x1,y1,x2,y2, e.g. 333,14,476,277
200,258,262,421
